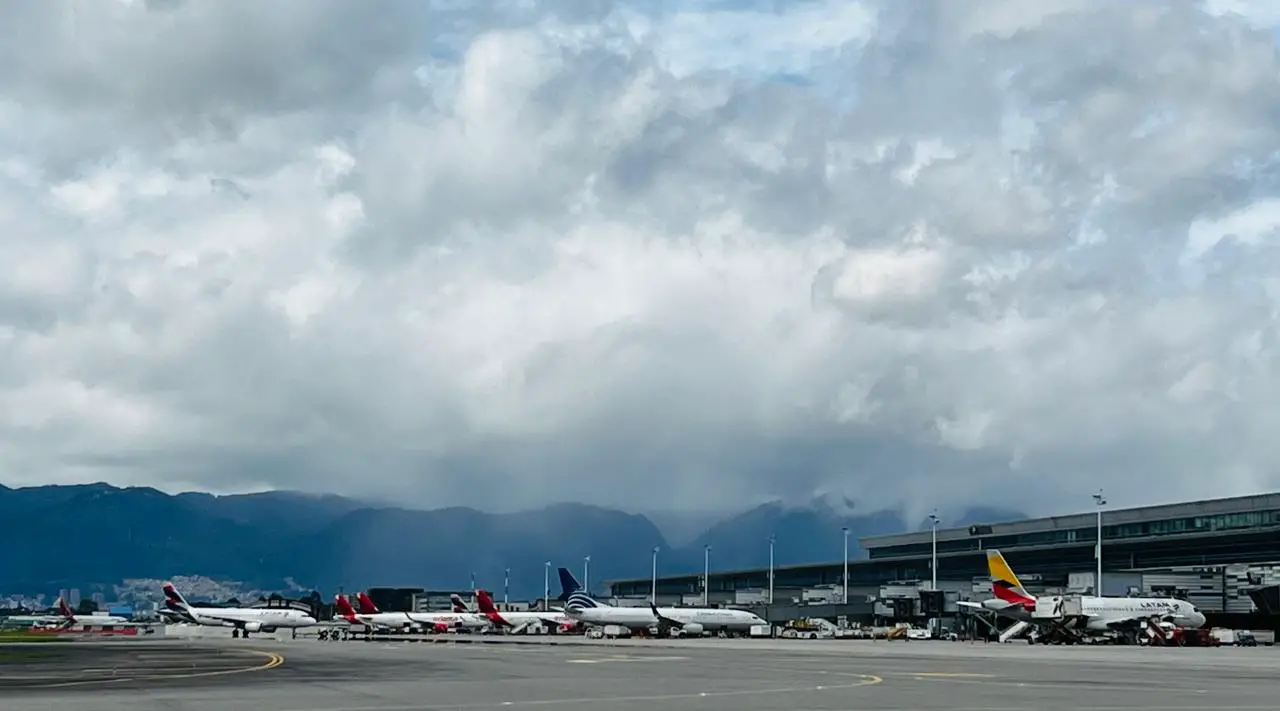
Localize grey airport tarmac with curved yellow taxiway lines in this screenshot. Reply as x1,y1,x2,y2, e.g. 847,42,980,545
0,639,1280,711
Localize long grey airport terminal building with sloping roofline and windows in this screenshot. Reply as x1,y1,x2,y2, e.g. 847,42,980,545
608,493,1280,619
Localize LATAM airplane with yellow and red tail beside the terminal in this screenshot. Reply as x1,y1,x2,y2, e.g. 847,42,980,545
960,550,1204,632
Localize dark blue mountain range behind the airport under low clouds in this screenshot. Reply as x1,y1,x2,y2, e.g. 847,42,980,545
0,483,1024,598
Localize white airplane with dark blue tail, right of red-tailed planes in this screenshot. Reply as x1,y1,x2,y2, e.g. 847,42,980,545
559,568,769,637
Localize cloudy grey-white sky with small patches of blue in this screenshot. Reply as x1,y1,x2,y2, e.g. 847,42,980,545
0,0,1280,518
